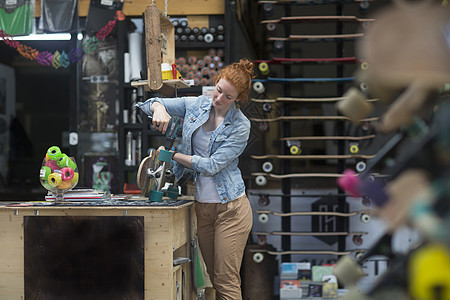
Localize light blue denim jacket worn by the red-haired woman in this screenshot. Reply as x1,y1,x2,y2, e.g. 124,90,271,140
136,96,250,203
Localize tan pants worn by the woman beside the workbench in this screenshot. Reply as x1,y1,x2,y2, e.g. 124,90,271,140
195,196,253,300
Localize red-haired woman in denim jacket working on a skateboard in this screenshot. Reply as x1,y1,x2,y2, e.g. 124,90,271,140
137,59,254,300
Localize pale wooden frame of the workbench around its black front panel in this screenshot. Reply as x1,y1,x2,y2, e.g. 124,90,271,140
0,202,196,300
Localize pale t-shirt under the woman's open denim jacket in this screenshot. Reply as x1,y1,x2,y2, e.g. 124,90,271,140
192,126,222,203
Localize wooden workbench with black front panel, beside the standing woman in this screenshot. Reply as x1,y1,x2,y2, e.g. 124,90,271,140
0,200,196,300
